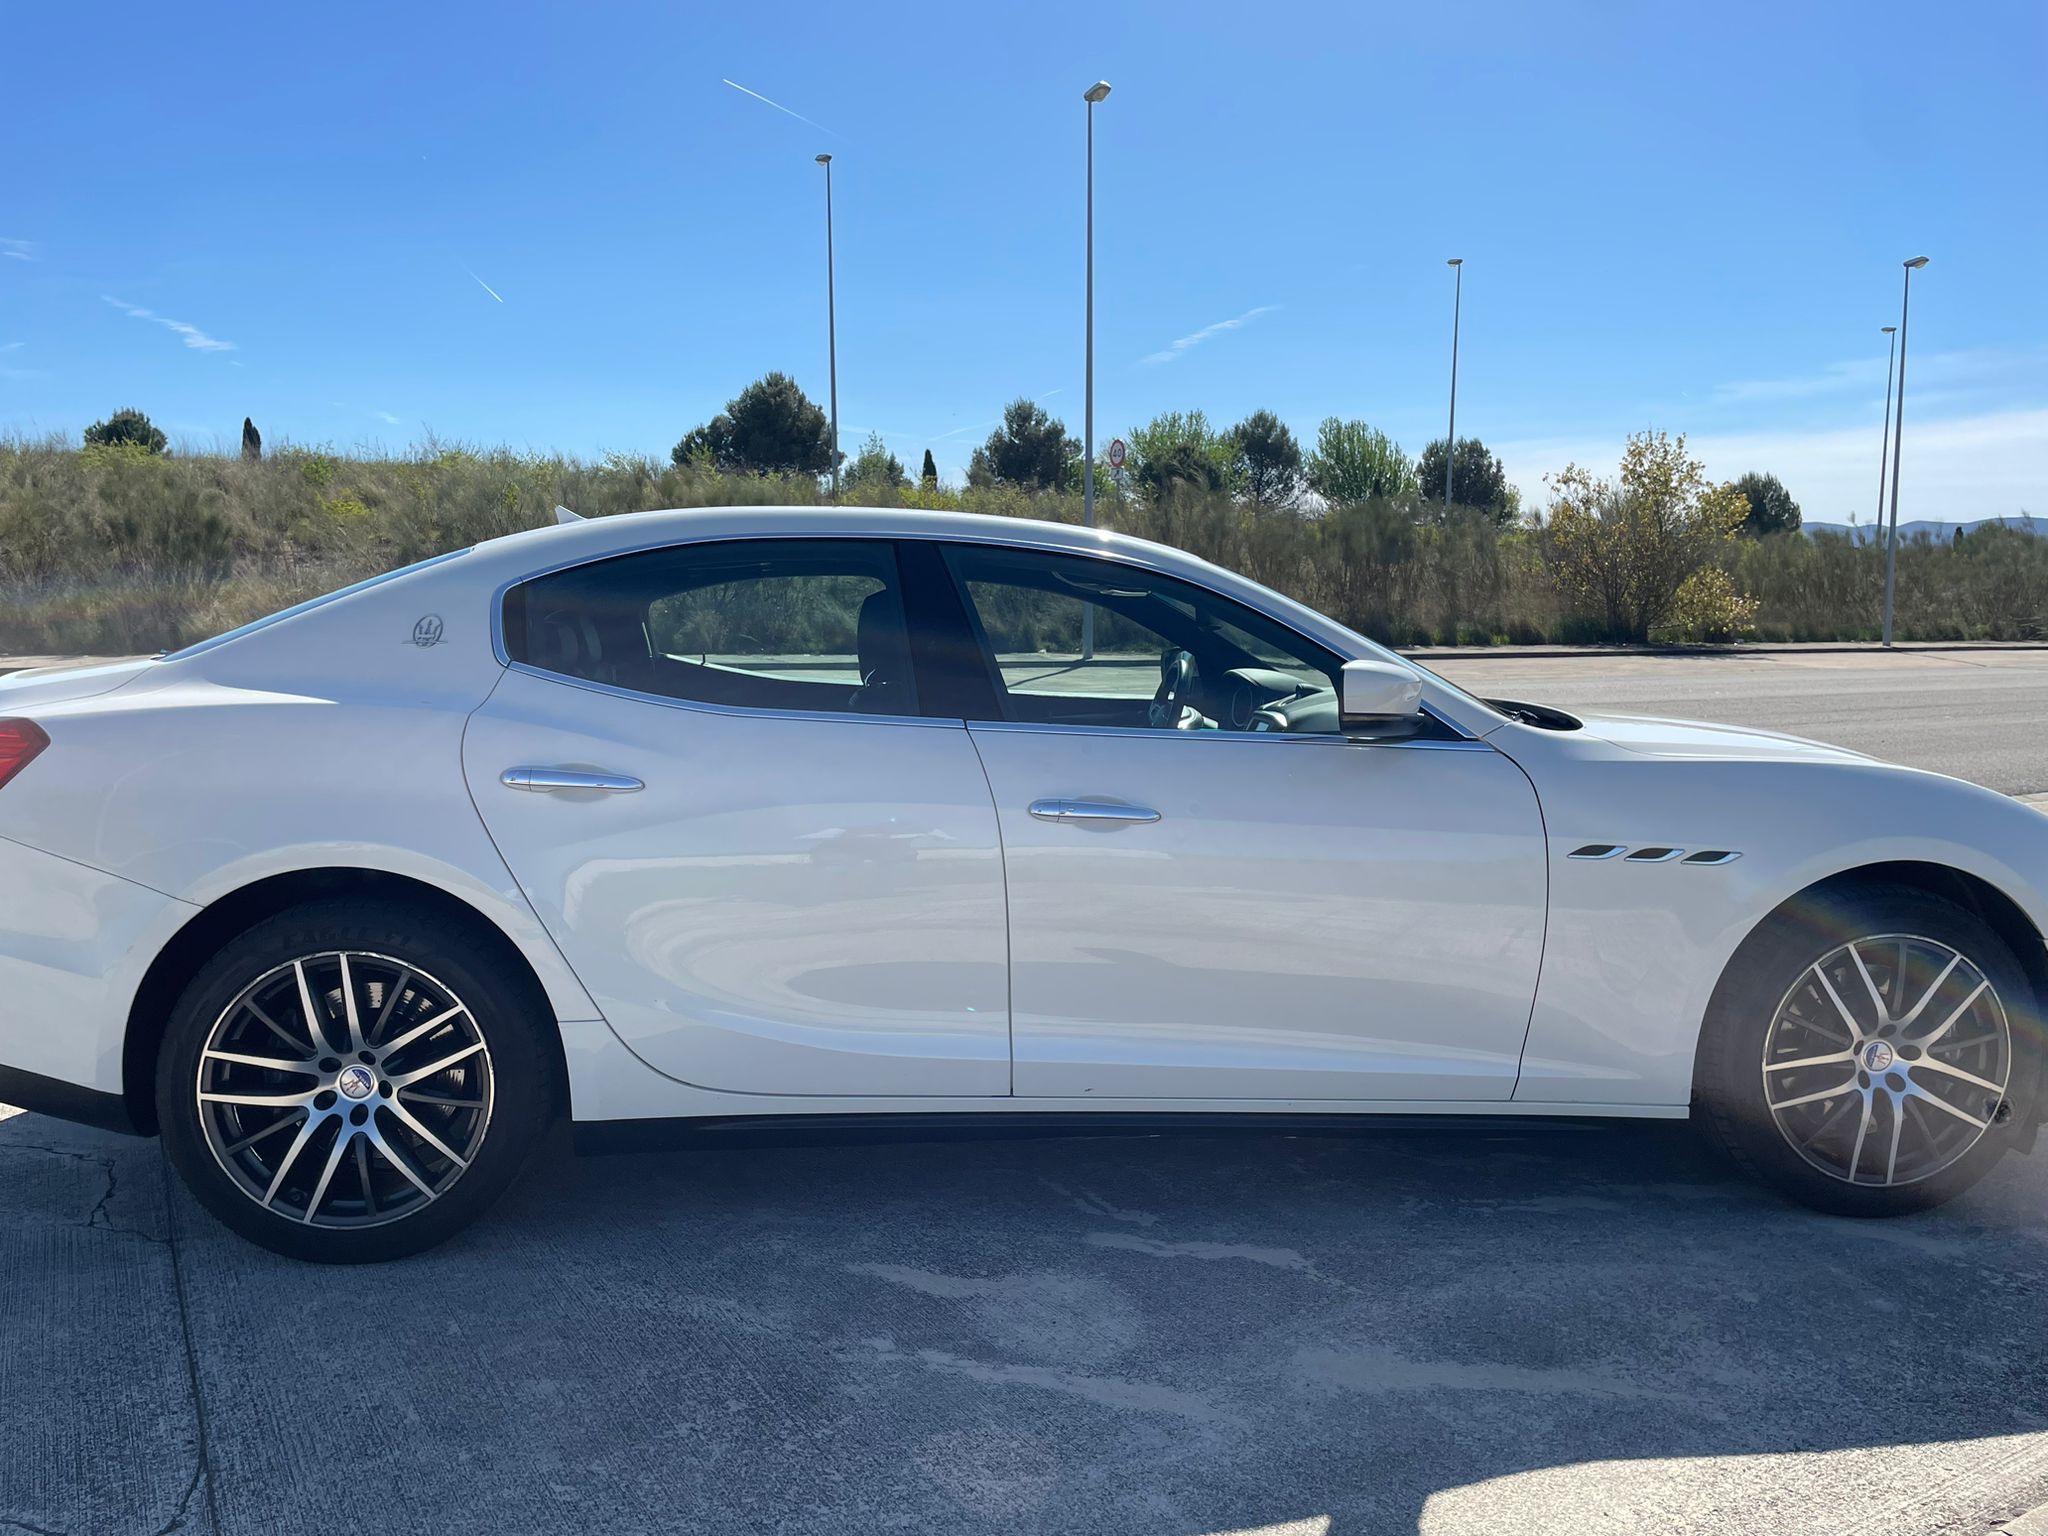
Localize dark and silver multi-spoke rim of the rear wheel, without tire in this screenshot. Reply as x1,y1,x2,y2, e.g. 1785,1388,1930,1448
195,950,494,1227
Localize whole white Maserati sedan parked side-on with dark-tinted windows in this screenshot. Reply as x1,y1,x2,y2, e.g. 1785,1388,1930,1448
0,508,2048,1262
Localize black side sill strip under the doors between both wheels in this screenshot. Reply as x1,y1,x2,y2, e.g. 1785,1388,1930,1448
573,1110,1669,1157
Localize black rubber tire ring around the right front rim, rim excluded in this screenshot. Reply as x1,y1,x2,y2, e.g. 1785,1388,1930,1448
1694,887,2042,1217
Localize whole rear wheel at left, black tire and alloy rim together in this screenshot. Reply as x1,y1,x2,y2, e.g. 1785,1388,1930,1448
156,897,561,1264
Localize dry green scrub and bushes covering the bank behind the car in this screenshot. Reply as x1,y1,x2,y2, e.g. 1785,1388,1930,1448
0,436,2048,653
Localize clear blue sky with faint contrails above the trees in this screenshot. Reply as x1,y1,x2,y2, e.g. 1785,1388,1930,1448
0,0,2048,520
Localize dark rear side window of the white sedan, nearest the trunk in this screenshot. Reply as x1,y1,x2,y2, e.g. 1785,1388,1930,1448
504,539,918,715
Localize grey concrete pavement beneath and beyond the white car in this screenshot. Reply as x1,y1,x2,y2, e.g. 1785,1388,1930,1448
0,651,2048,1536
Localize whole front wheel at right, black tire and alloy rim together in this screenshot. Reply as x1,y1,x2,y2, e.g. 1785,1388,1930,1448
1694,885,2042,1217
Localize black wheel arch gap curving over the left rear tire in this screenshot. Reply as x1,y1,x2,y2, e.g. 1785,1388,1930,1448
121,866,569,1135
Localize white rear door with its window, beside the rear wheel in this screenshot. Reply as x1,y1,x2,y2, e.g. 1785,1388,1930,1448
463,539,1010,1096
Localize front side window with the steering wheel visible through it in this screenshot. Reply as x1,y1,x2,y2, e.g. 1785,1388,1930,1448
946,545,1341,733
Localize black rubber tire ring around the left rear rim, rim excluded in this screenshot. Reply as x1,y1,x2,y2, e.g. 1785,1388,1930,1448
156,897,559,1264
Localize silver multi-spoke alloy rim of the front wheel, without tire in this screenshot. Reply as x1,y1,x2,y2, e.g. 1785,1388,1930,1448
1761,934,2013,1188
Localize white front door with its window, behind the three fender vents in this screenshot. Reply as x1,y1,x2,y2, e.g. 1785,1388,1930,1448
946,545,1546,1102
